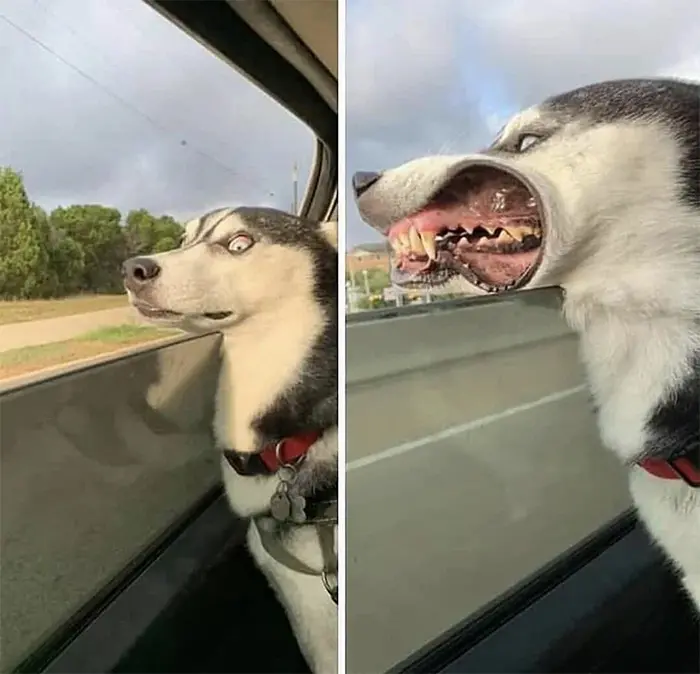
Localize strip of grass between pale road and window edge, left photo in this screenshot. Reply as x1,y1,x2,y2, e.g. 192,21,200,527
0,325,178,379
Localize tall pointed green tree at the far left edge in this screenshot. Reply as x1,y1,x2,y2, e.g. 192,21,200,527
0,167,50,299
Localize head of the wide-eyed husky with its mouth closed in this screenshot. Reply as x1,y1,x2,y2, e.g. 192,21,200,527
122,207,338,332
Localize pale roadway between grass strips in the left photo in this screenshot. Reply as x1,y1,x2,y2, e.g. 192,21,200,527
0,307,141,351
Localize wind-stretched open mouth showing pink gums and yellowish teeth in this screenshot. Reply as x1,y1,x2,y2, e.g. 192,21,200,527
387,166,544,293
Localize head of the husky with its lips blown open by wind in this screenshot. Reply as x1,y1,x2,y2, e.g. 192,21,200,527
353,79,700,312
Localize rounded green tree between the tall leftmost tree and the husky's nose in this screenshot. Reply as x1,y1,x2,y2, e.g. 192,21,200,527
49,204,128,293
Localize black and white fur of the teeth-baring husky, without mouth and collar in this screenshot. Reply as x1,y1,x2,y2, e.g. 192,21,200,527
358,79,700,609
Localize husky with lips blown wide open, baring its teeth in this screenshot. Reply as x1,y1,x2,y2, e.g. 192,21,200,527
353,79,700,608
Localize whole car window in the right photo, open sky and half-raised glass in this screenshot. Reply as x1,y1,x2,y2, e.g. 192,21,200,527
345,0,700,674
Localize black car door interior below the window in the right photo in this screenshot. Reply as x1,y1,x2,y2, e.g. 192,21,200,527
387,508,700,674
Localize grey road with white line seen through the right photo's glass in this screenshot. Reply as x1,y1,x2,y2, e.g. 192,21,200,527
347,292,628,674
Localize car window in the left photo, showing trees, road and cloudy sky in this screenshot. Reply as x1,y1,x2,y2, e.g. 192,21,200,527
0,0,316,671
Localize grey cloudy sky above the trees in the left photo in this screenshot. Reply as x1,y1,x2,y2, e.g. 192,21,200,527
0,0,314,226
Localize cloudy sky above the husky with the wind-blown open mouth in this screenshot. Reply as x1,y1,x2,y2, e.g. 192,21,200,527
345,0,700,246
